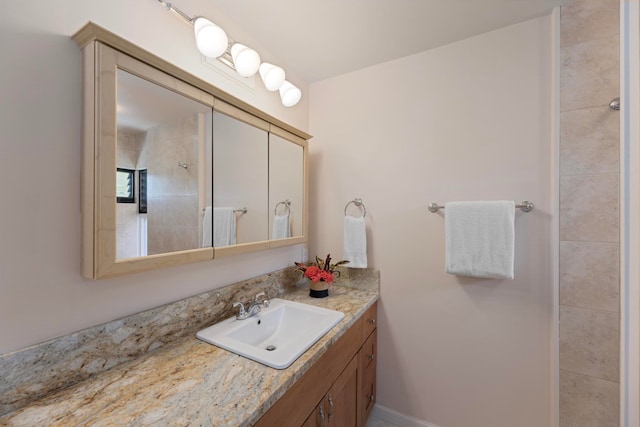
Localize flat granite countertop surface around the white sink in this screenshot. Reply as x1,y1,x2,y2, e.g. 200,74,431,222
0,286,378,427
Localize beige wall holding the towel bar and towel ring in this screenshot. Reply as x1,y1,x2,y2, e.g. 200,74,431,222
309,16,553,427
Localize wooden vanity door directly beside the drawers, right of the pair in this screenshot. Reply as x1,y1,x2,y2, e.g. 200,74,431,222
324,355,358,427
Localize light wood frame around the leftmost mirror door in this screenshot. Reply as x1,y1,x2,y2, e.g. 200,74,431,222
82,42,213,279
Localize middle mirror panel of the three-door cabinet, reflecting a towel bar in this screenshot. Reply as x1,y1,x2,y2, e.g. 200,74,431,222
212,107,269,247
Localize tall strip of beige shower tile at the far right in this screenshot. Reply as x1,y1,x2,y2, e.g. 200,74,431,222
559,0,620,427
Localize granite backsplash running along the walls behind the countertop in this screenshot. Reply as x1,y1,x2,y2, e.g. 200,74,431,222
0,267,379,416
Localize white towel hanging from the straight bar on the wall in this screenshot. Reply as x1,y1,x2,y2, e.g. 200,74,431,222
444,201,515,279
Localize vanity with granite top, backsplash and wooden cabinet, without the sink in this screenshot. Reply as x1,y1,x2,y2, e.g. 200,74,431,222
0,269,378,427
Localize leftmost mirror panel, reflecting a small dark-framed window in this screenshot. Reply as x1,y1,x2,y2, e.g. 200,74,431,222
116,69,212,259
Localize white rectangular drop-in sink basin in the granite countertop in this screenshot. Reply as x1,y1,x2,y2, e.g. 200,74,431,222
196,298,344,369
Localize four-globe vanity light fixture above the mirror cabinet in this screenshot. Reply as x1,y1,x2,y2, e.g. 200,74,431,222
158,0,302,107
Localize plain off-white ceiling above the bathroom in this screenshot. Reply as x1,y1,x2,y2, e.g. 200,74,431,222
209,0,570,83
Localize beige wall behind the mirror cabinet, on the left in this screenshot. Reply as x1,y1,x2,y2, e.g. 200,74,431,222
0,0,308,353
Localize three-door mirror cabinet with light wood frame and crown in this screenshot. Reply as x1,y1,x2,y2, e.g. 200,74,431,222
73,23,310,279
